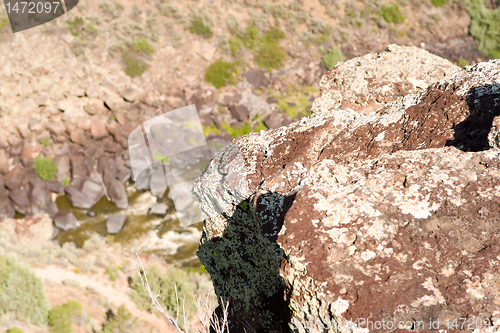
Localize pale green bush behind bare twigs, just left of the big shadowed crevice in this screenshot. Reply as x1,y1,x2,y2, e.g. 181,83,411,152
129,265,196,326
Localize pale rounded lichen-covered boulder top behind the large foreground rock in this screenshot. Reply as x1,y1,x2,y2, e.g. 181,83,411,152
312,45,459,113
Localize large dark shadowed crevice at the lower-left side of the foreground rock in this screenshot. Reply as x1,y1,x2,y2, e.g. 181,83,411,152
197,193,295,333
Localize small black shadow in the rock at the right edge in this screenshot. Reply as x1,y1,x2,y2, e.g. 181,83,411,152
445,83,500,152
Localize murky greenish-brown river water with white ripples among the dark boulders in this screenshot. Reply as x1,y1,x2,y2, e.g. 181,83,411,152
55,184,203,267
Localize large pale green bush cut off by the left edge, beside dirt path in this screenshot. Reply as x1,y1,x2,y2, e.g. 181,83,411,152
0,255,50,325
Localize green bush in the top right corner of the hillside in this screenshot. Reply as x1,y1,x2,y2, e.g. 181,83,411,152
464,0,500,58
